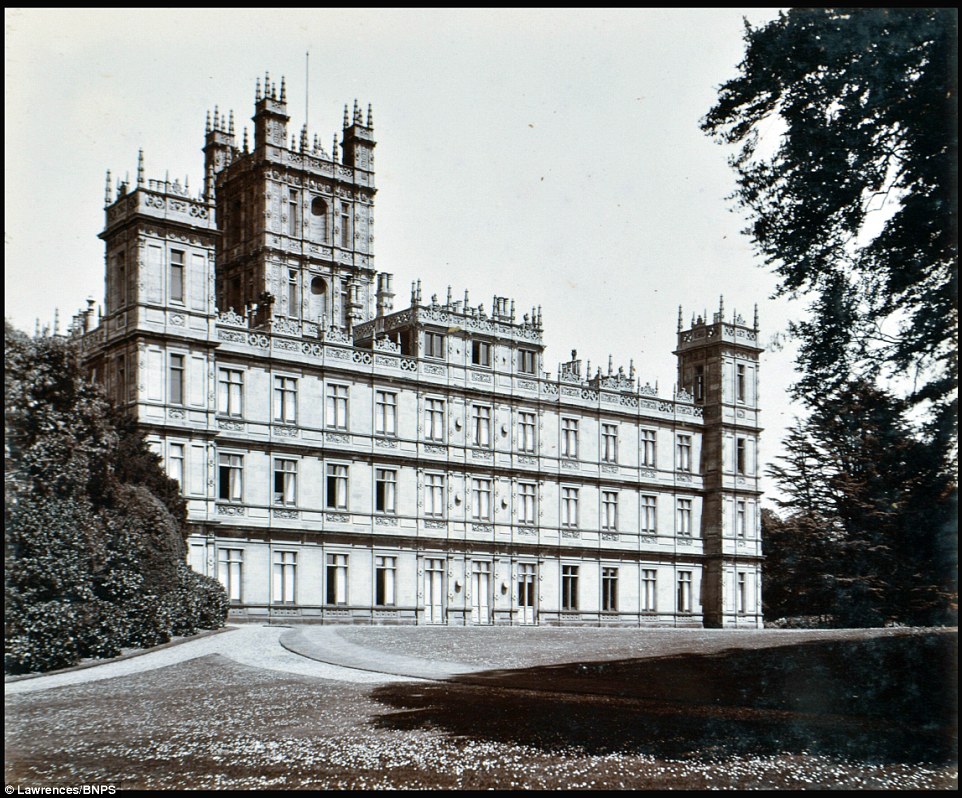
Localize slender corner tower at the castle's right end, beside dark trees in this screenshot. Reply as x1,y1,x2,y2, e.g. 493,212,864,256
675,300,763,628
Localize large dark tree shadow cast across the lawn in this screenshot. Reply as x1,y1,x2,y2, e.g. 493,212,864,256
374,633,958,763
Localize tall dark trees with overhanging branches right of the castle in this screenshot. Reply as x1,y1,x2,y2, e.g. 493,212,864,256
702,8,958,625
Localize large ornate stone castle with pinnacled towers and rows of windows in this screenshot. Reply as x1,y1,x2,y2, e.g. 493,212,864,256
74,76,762,627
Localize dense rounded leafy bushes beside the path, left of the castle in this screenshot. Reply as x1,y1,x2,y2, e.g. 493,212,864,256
4,325,227,672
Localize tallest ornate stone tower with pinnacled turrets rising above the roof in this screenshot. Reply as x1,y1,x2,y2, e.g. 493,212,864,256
204,75,376,332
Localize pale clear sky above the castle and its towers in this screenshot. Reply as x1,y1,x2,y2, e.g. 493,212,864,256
4,8,804,504
